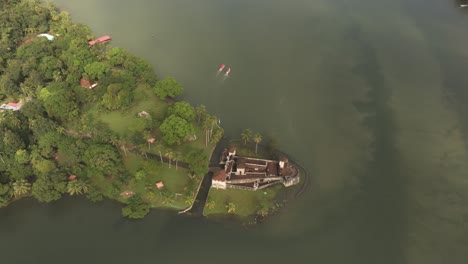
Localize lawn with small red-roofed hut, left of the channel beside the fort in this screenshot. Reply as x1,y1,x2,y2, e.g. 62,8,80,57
124,153,200,209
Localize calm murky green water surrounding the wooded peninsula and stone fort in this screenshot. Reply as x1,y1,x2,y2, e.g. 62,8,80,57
0,0,468,264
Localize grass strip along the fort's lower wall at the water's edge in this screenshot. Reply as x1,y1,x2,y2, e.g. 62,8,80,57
203,184,285,217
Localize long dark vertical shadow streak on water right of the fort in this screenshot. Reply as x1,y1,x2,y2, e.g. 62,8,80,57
347,26,407,264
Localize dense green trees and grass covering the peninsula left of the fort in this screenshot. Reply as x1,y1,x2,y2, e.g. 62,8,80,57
0,0,223,218
